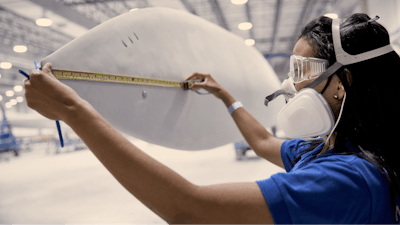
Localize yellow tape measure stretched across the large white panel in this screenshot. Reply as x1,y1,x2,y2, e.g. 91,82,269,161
52,69,202,90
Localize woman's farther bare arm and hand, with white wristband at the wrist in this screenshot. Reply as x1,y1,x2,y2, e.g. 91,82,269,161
187,73,284,168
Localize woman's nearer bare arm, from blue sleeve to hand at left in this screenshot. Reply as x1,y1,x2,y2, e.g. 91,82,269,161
25,64,273,224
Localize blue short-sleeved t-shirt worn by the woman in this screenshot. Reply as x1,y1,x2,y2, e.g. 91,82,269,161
257,139,400,224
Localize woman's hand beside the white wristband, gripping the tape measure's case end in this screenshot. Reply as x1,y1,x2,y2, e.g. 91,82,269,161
186,73,226,99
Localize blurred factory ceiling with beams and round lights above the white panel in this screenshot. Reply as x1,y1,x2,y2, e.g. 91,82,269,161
0,0,372,106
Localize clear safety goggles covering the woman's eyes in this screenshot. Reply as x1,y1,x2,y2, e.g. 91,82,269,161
288,55,329,83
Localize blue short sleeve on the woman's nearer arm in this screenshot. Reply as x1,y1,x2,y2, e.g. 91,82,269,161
257,161,371,224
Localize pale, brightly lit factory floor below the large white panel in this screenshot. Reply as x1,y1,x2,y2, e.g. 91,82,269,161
0,138,284,224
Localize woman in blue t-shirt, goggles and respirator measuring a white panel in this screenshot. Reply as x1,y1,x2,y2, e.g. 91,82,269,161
25,14,400,224
